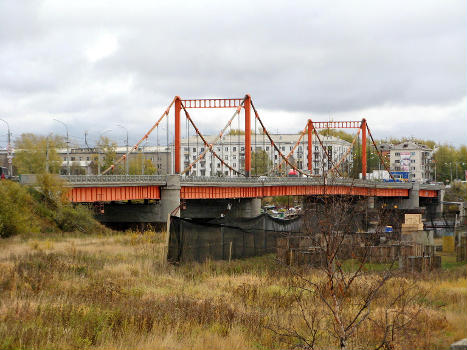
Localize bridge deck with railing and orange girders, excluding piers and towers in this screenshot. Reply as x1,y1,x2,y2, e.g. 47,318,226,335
54,175,441,202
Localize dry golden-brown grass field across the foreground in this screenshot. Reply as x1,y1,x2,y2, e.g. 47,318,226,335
0,232,467,349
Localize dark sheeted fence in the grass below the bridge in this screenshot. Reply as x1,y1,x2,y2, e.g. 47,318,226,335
167,214,302,262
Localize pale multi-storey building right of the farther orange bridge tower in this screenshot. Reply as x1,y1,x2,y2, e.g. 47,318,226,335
390,141,433,182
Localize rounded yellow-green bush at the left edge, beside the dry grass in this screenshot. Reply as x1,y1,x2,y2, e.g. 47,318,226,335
0,180,38,238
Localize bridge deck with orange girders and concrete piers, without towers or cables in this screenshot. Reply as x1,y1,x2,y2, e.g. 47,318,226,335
44,174,444,222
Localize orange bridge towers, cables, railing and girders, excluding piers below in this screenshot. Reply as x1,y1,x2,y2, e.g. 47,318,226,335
32,95,443,216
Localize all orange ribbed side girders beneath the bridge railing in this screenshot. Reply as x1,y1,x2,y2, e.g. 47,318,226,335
68,185,438,203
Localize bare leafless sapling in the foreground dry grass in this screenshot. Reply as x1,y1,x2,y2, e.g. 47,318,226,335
265,179,421,349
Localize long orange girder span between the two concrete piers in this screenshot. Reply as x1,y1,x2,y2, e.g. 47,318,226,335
180,185,409,199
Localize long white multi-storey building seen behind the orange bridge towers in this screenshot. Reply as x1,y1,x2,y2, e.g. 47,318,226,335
181,134,352,176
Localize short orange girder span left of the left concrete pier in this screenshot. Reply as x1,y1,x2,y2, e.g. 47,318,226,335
67,186,161,203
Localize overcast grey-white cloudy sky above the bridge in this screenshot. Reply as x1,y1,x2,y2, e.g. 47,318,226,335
0,0,467,147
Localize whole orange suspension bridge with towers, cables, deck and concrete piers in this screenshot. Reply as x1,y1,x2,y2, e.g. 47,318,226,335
19,95,444,222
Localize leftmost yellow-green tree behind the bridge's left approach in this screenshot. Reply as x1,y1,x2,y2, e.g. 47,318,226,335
13,133,66,174
